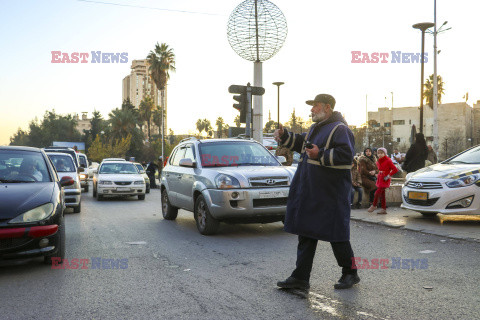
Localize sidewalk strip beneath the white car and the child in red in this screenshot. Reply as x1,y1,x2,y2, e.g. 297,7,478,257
351,207,480,242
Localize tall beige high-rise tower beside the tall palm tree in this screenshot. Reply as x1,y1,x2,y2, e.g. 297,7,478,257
122,60,168,134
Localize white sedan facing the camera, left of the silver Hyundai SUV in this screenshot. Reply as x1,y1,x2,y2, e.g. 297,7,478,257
93,161,146,200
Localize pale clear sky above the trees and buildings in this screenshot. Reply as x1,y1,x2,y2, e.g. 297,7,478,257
0,0,480,145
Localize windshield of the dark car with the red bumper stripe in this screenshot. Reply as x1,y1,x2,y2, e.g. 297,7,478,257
0,150,52,183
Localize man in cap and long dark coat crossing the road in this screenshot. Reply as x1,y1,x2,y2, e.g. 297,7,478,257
275,94,360,290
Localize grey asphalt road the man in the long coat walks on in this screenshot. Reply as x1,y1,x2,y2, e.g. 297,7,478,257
0,186,480,319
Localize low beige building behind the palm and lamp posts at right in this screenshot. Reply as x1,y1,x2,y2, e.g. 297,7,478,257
368,100,480,156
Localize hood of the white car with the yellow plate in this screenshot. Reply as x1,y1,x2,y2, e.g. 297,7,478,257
409,163,480,180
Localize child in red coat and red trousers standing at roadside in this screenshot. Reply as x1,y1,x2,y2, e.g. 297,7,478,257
368,148,398,214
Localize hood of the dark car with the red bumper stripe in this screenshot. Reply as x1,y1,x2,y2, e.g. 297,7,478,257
0,182,55,219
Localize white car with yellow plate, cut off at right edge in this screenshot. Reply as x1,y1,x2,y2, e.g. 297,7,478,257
402,146,480,215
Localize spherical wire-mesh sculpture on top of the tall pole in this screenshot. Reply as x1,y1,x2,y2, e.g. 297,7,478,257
227,0,288,61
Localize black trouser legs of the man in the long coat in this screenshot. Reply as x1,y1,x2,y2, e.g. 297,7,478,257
292,236,357,281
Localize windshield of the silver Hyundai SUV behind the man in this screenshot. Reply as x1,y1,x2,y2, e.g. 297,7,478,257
199,141,280,167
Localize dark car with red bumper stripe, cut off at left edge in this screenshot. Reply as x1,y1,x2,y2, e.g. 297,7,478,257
0,146,73,264
